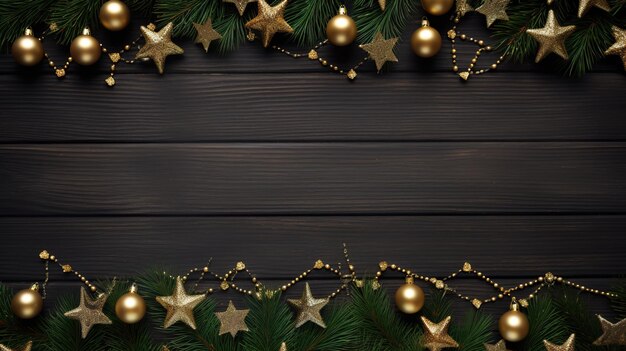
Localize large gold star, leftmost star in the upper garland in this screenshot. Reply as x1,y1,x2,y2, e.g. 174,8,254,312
135,22,185,74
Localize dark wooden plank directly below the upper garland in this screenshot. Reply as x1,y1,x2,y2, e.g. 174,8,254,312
0,73,626,143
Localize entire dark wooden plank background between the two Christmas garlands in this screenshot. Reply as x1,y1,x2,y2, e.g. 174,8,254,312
0,15,626,318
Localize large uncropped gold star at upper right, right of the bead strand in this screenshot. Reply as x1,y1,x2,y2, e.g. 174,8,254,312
526,10,576,62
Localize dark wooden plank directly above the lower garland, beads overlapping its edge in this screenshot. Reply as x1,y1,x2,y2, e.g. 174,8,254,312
0,216,626,281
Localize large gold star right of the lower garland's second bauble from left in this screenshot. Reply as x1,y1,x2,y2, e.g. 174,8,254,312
156,277,206,330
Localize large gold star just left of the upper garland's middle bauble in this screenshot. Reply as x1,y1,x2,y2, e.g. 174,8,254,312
246,0,293,47
